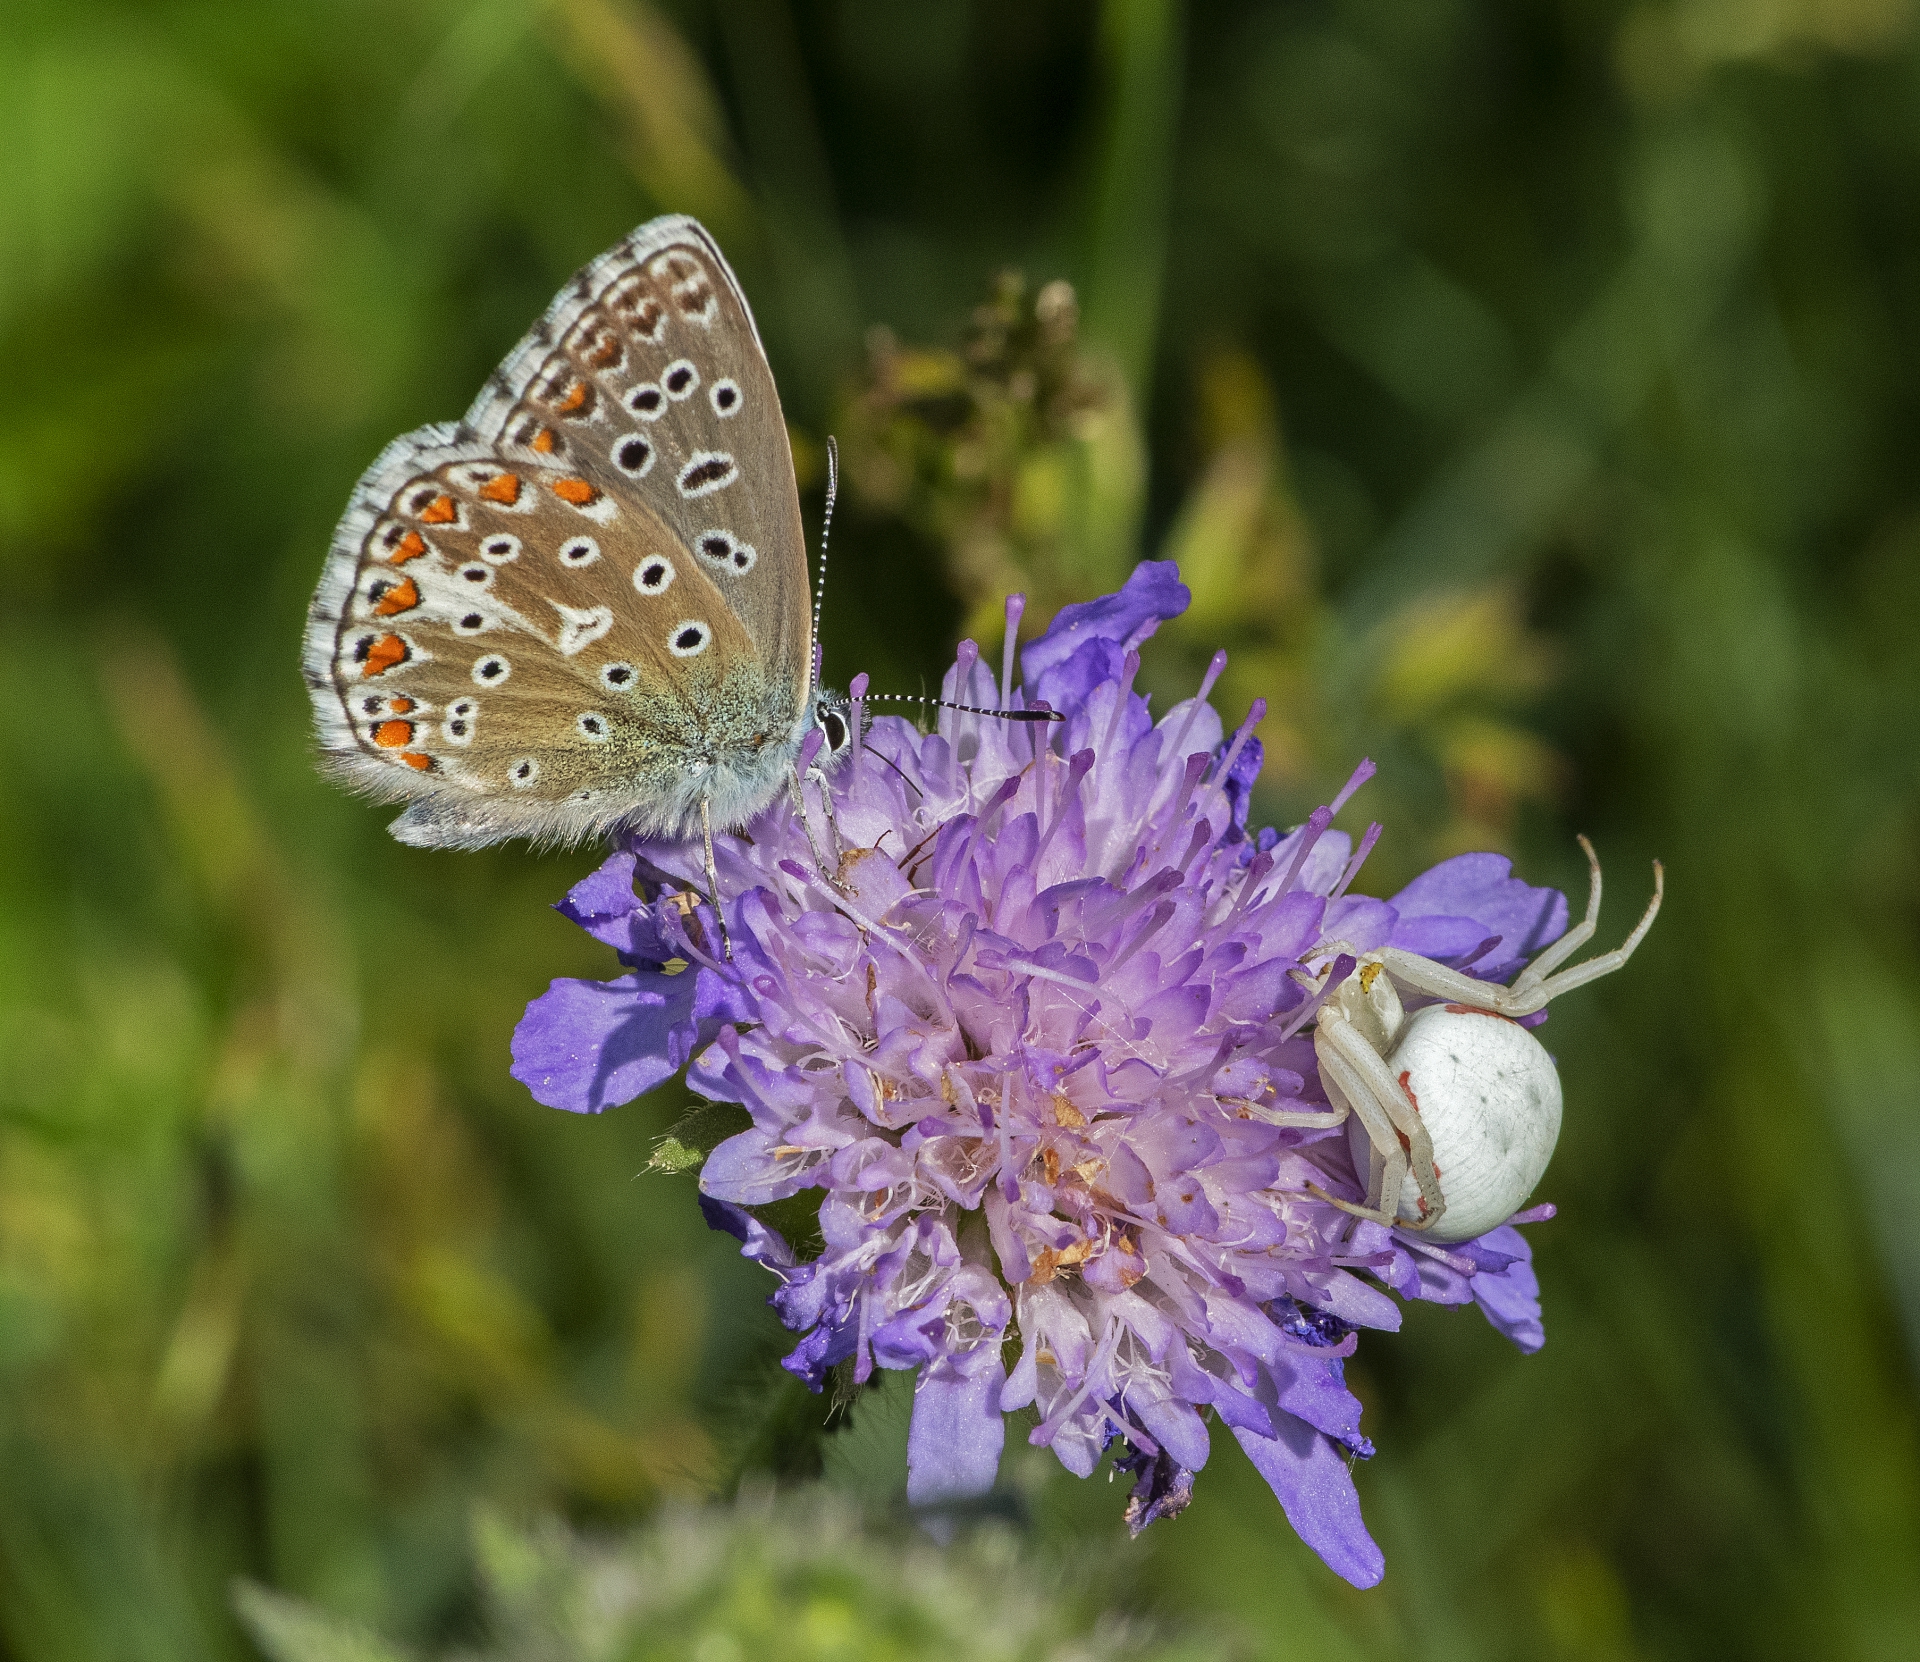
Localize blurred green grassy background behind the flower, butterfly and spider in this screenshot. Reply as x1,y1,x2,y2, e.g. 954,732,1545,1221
0,0,1920,1662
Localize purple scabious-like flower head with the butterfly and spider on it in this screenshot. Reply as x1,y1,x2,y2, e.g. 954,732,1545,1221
515,564,1567,1585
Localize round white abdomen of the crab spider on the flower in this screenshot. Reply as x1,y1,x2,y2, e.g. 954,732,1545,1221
1386,1004,1561,1242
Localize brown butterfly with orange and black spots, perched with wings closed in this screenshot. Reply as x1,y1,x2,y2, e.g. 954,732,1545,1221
303,217,847,871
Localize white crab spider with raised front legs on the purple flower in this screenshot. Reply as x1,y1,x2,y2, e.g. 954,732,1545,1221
1271,837,1665,1242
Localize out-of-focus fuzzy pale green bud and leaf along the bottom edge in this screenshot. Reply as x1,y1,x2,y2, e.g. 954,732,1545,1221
234,1489,1227,1662
